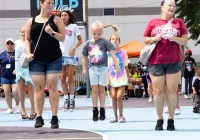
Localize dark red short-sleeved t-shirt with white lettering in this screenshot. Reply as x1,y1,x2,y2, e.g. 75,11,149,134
144,18,188,64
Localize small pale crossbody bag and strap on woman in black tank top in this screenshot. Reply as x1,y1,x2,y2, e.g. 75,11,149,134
19,16,51,68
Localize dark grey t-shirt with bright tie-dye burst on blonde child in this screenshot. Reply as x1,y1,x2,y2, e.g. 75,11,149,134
82,38,115,66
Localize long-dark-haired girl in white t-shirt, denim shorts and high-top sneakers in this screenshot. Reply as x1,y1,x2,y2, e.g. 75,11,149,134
60,10,82,111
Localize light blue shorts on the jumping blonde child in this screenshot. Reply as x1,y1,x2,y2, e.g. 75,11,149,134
89,66,108,86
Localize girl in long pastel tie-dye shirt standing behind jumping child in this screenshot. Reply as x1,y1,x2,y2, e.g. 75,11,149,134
107,34,130,123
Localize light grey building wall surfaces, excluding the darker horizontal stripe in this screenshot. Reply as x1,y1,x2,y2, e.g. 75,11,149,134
0,0,200,61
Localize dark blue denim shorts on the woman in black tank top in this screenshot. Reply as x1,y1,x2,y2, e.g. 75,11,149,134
29,57,62,75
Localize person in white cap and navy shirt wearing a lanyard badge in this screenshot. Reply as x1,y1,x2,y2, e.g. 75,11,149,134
0,38,21,114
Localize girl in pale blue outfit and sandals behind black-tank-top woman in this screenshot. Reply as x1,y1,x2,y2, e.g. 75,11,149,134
15,26,36,120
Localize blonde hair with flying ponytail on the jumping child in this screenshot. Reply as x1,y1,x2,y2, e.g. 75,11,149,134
90,21,119,32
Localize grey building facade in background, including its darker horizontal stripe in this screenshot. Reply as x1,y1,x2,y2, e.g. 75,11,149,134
0,0,200,60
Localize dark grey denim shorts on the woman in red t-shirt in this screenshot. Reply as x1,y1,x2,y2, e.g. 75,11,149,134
148,62,182,76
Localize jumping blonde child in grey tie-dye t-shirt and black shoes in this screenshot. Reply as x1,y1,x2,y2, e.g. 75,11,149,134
82,21,120,122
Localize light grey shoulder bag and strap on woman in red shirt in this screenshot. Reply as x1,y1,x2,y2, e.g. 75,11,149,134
140,18,173,65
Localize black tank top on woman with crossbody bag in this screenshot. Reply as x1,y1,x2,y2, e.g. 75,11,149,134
31,16,62,62
